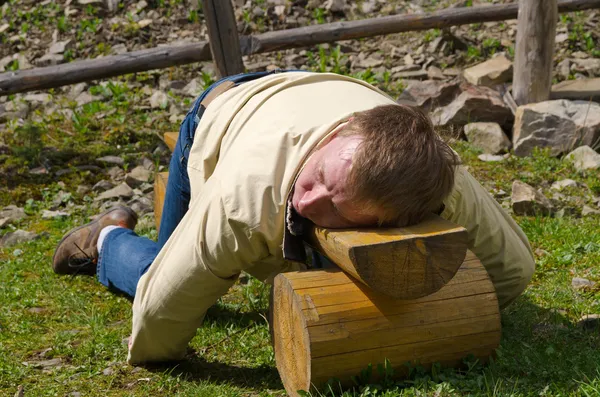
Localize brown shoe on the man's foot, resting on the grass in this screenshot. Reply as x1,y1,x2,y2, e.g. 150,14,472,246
52,206,137,274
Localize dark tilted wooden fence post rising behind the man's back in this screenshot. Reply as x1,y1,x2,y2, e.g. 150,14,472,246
202,0,244,77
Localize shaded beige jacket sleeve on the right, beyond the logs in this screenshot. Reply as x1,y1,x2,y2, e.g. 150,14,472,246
441,166,535,308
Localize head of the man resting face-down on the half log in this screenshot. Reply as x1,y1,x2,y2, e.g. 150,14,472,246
292,105,458,228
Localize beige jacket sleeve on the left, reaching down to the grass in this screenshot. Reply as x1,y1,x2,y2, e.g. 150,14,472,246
127,178,268,364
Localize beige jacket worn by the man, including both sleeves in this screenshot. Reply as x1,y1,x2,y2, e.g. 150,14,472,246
128,72,533,363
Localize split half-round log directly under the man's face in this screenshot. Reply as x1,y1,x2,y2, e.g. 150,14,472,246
309,215,468,299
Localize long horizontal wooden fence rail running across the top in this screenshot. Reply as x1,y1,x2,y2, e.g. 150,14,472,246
0,0,600,95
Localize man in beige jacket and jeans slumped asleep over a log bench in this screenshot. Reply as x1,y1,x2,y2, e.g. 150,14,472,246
53,72,534,363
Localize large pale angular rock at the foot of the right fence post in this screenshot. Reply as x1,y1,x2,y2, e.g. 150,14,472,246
513,99,600,156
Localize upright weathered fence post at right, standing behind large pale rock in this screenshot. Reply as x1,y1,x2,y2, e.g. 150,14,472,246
513,0,558,105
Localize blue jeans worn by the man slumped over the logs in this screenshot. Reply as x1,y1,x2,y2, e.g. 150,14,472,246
96,72,288,297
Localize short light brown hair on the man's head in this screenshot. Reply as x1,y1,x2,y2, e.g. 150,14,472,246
340,105,459,226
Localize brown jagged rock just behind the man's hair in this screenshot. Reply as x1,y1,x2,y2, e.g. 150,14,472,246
431,85,514,129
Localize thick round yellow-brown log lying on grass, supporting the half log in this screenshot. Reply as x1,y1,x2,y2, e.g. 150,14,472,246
272,252,501,396
